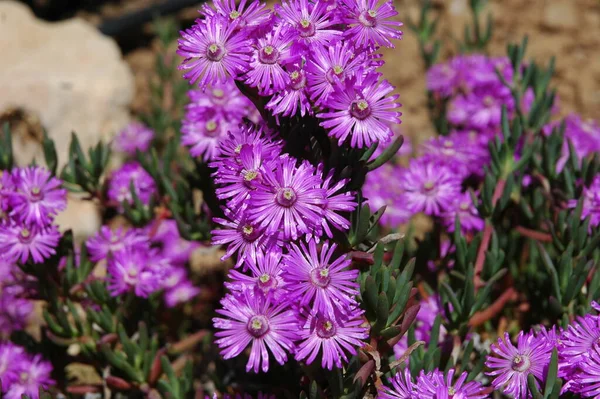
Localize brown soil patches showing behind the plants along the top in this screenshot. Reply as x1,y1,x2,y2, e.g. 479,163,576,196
79,0,600,142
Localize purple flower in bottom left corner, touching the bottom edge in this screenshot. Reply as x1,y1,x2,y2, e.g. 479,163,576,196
4,355,55,399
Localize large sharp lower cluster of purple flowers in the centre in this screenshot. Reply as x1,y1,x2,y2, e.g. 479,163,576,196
212,123,367,372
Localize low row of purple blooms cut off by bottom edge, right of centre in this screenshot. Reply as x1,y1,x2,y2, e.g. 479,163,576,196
378,369,488,399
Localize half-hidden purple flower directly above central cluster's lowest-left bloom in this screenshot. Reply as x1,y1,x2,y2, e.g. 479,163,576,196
225,251,285,299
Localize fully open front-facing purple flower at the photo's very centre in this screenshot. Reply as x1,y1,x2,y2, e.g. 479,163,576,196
249,154,325,240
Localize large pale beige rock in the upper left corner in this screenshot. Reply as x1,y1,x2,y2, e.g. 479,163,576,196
0,1,134,165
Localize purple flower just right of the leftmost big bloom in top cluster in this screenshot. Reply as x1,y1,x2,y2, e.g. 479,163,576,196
246,25,292,95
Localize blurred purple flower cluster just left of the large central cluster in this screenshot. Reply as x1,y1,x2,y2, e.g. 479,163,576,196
86,220,199,307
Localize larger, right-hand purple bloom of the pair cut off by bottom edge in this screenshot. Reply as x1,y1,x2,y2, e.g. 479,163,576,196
417,369,488,399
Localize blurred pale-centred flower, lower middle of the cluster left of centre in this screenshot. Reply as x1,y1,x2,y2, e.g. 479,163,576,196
106,250,161,298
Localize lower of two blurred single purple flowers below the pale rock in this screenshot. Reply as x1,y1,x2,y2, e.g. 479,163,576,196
108,162,156,205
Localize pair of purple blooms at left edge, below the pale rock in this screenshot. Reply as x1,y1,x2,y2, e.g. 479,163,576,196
0,166,67,264
